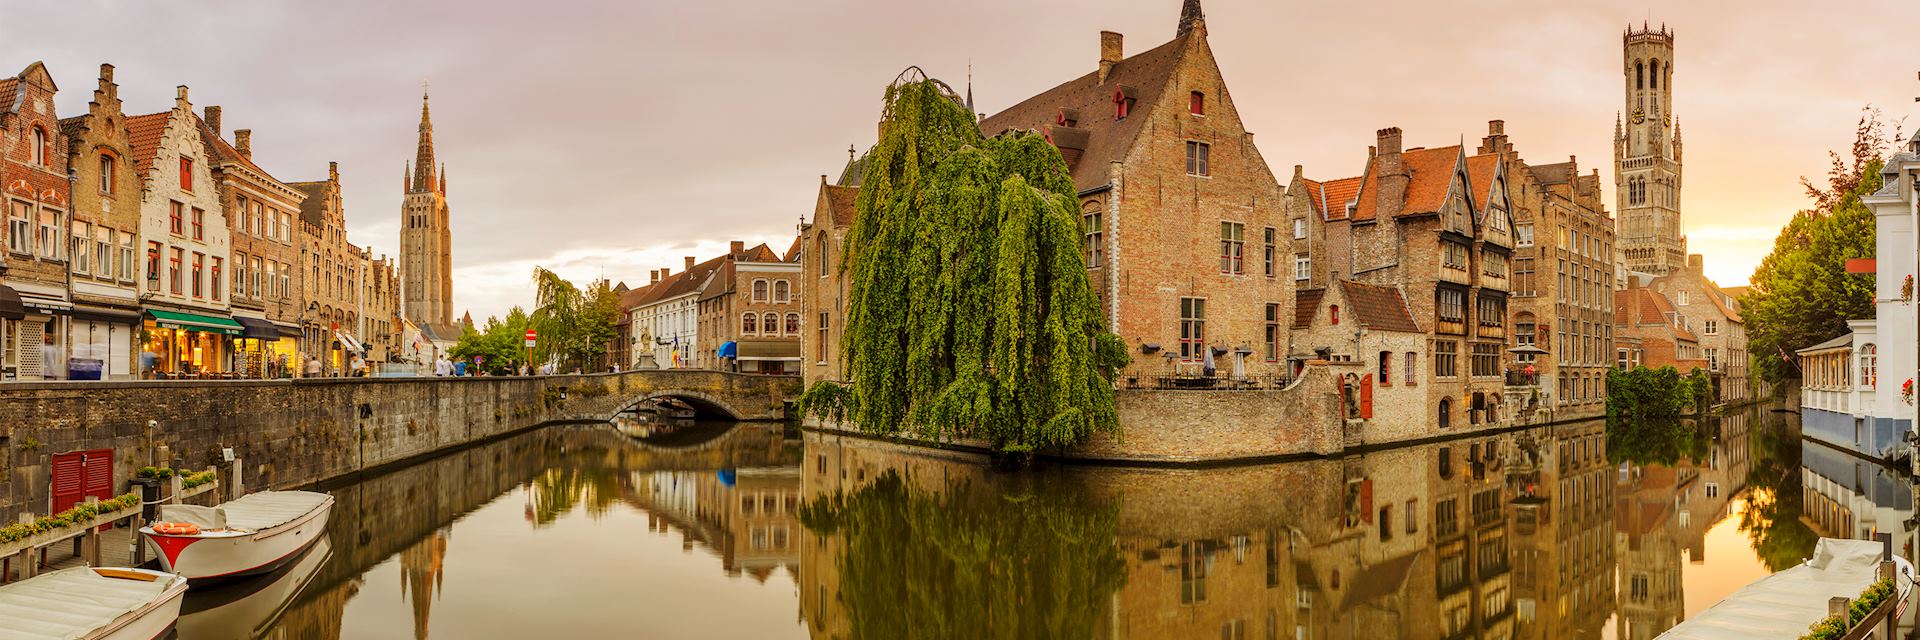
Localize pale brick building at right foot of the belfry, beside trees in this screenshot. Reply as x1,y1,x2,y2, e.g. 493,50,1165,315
1645,254,1753,402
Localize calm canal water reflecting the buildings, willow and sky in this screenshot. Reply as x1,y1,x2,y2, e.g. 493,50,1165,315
177,401,1914,640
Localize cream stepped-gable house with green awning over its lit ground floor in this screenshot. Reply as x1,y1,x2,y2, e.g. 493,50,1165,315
127,85,244,377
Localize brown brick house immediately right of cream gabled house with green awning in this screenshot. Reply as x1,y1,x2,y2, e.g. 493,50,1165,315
200,106,307,379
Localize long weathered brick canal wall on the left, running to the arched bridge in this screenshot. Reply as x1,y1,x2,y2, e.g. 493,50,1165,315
0,371,799,523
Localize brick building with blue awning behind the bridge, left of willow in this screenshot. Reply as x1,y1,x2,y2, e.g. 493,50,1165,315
695,240,803,373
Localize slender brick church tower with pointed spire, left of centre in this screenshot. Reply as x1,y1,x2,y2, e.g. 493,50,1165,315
399,94,453,327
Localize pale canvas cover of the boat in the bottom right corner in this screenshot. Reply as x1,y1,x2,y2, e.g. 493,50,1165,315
1659,538,1912,640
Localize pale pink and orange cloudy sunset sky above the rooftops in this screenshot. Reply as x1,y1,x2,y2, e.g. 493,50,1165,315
15,0,1920,317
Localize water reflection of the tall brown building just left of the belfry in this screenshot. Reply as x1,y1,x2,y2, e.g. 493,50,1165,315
1507,421,1615,640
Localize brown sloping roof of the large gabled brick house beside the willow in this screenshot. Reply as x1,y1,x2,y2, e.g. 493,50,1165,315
983,33,1192,190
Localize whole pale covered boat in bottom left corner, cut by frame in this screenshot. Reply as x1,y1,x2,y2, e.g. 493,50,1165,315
0,567,186,640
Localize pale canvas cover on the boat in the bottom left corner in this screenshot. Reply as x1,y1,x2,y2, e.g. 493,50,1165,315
0,567,186,640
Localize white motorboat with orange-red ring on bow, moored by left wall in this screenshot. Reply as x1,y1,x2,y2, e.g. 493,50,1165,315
140,492,334,580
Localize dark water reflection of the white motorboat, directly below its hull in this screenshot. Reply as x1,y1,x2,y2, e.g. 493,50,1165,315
179,536,332,640
